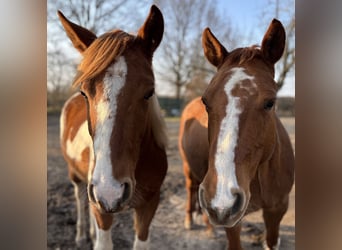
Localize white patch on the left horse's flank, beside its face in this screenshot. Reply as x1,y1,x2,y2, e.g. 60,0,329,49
66,121,93,161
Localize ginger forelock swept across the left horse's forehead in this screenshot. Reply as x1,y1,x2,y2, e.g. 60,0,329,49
73,30,135,87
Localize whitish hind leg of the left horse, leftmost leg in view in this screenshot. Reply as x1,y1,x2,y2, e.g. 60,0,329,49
71,180,88,247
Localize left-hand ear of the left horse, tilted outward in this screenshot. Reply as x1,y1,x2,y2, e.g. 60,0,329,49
57,11,96,54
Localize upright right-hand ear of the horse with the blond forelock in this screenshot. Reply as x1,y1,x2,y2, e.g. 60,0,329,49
137,5,164,57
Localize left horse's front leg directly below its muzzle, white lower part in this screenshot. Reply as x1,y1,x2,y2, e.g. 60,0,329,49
91,205,113,250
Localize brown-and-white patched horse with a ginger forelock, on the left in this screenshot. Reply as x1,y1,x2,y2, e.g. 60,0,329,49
58,6,167,249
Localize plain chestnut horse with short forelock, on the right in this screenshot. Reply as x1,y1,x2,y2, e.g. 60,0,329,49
179,19,294,249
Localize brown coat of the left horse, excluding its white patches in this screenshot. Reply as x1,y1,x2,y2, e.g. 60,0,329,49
59,6,167,247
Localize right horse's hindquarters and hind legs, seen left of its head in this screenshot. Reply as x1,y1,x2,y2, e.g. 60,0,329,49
178,98,214,232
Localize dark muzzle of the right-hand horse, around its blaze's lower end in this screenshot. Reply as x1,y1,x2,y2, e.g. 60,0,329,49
199,185,247,227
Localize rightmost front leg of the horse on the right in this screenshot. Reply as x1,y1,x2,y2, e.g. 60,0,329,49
263,201,288,250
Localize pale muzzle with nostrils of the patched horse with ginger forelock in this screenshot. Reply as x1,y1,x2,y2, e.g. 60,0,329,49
88,179,134,213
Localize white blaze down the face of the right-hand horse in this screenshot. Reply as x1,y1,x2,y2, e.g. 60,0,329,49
211,68,253,209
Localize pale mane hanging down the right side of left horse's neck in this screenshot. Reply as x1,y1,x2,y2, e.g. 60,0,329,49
149,95,168,148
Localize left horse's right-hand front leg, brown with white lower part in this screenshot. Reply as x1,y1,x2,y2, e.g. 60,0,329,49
133,192,160,250
